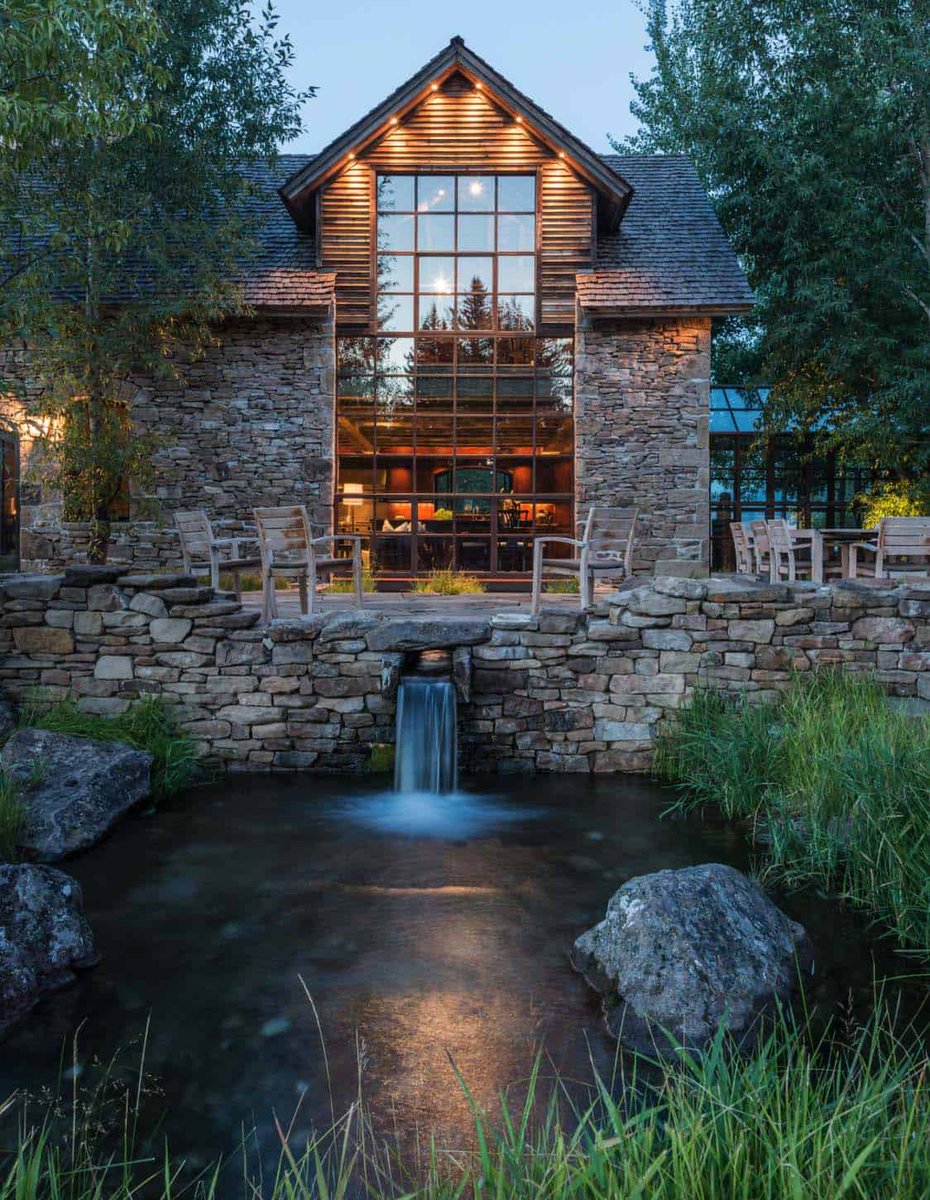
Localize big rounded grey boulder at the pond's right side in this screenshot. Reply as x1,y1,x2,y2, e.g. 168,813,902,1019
571,863,812,1054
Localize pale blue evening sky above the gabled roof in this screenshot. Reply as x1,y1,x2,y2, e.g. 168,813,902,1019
256,0,653,154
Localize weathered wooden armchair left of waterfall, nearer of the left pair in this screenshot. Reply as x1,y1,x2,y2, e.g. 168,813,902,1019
254,504,362,620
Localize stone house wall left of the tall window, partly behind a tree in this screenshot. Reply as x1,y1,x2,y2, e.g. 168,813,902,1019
0,317,335,570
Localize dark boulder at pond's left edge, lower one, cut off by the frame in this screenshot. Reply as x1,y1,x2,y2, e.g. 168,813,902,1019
0,864,97,1033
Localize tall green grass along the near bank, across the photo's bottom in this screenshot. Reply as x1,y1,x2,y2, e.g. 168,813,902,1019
0,1014,930,1200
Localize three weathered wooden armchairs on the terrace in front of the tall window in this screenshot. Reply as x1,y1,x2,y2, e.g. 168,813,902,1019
174,504,637,620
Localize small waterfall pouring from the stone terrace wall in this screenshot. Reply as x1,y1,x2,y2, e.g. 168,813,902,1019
394,677,458,794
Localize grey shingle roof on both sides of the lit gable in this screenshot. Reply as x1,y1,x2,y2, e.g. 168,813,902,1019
246,155,752,314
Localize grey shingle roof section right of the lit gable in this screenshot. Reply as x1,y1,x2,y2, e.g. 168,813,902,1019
590,155,754,313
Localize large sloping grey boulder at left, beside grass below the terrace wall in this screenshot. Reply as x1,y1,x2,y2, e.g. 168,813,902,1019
0,730,152,863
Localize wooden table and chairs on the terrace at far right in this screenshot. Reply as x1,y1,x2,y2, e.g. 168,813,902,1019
730,517,930,583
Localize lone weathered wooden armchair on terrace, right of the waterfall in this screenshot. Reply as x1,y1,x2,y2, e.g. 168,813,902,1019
532,504,638,612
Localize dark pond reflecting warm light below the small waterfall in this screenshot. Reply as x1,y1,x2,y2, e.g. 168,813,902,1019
0,775,918,1162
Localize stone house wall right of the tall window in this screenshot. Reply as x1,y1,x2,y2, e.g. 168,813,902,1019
575,311,710,575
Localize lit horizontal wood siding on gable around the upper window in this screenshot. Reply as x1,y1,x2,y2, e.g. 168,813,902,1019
319,76,595,331
